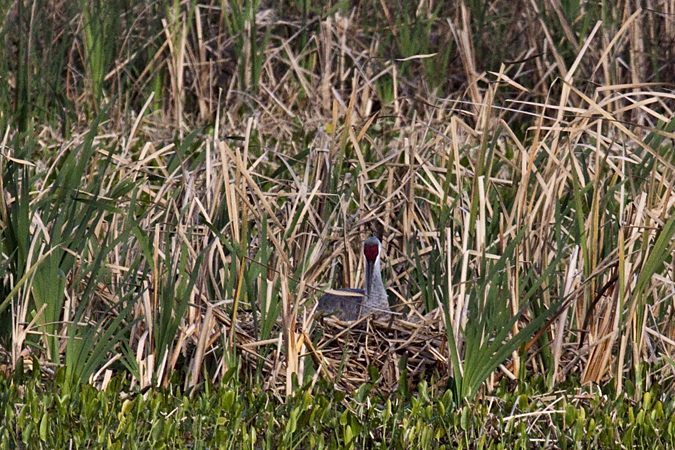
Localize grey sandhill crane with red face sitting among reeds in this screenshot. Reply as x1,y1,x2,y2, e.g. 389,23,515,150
318,236,389,320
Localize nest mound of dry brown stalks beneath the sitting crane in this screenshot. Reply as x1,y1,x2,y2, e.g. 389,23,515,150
214,309,448,393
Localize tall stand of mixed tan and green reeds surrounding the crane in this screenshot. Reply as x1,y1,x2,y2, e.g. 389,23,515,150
0,1,675,399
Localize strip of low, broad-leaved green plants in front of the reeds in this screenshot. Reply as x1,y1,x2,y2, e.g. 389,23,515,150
0,361,675,449
